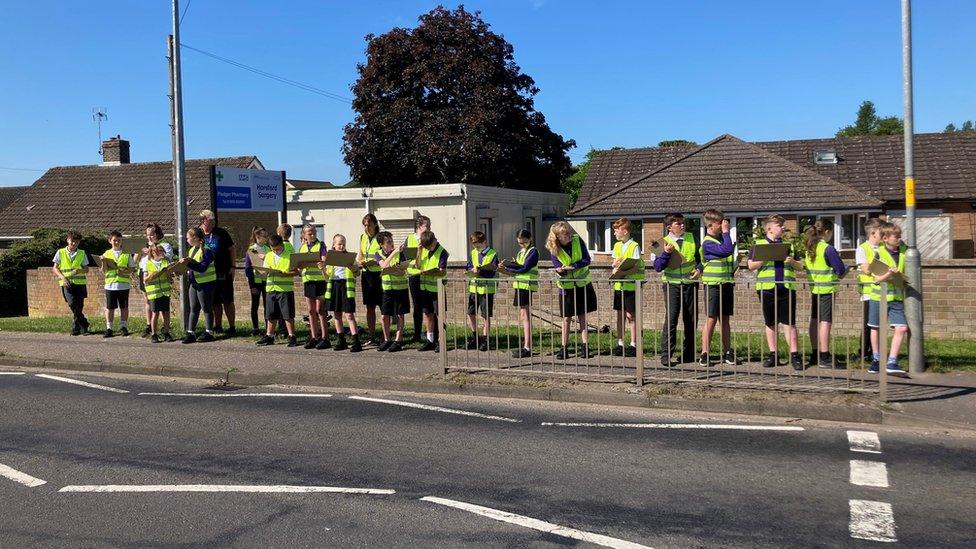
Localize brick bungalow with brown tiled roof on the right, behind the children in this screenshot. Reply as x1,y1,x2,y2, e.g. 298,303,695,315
567,133,976,258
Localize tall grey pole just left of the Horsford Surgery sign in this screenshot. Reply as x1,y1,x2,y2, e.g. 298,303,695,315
168,0,190,329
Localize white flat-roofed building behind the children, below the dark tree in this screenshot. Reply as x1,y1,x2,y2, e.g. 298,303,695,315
287,183,567,263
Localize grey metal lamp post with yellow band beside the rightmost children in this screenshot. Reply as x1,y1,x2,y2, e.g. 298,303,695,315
900,0,925,374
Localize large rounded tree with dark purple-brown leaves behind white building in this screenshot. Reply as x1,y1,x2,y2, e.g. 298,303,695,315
342,6,575,191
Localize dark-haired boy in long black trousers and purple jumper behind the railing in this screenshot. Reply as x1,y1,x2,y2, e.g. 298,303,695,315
654,214,702,368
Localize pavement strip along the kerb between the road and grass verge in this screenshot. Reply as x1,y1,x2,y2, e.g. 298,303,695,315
0,332,976,430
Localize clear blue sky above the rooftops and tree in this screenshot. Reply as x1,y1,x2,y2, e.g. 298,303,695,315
0,0,976,185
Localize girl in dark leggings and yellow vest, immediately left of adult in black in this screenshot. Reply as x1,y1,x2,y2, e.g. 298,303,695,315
180,227,217,344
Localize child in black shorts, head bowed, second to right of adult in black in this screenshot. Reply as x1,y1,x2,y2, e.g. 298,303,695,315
257,234,298,347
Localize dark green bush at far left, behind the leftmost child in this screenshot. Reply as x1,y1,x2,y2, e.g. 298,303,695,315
0,227,108,316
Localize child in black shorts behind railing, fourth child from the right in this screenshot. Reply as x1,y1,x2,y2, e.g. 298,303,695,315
747,215,803,371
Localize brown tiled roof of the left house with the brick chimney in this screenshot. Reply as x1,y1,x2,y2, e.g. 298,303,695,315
0,156,256,236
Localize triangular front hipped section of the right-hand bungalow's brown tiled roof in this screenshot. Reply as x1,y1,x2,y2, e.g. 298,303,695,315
570,135,881,216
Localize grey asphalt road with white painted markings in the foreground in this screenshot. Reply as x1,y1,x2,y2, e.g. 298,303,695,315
0,373,976,548
